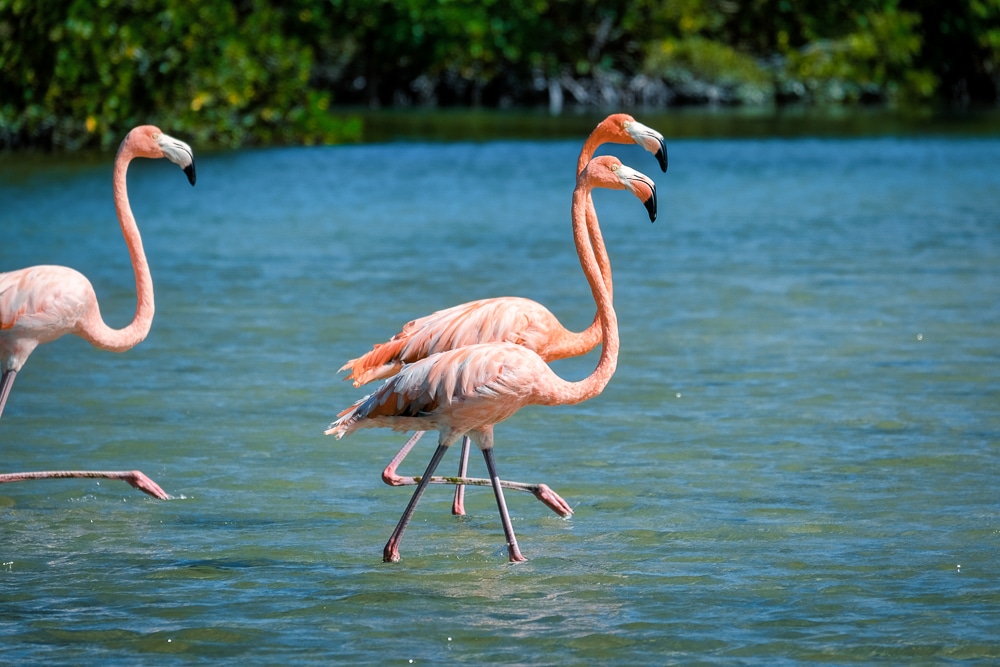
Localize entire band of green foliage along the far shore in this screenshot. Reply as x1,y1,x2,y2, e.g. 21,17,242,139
0,0,1000,149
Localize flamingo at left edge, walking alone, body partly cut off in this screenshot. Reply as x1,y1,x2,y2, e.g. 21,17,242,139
0,125,195,500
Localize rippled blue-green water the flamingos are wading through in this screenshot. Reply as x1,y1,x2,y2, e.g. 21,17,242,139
0,127,1000,665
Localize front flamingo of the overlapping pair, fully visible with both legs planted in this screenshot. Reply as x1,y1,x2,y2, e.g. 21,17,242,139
325,156,656,563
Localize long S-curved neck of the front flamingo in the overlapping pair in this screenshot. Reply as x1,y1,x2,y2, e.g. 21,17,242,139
552,183,619,405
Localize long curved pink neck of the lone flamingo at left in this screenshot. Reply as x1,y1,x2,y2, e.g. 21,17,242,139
81,137,155,352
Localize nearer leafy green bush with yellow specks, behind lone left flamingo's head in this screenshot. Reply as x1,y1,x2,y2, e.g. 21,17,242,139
0,0,360,148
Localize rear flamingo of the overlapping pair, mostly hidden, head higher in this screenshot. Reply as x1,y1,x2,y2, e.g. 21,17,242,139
340,113,667,517
